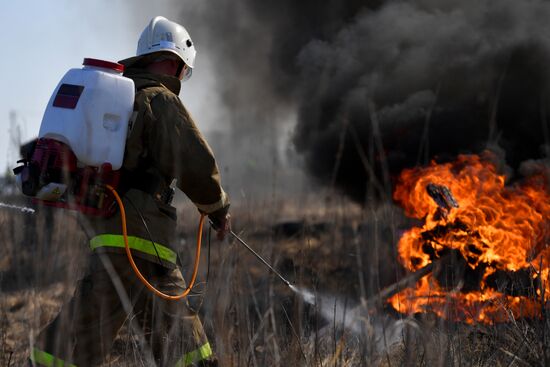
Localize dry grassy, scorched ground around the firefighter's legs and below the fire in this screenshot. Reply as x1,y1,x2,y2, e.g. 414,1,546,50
0,194,550,366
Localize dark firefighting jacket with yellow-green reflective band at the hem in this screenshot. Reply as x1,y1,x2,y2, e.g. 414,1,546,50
90,68,229,267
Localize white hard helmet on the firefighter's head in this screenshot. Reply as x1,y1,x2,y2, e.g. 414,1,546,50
136,16,197,76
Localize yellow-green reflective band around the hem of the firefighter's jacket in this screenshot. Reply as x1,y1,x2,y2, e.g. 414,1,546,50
90,234,177,264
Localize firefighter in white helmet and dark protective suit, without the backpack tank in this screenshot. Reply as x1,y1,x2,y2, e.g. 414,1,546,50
31,16,230,367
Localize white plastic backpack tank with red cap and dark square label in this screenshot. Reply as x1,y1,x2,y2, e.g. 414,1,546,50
39,58,135,170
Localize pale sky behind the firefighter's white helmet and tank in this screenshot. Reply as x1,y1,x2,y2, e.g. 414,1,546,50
0,0,223,173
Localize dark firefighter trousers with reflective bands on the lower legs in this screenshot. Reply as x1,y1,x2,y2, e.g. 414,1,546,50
31,252,217,367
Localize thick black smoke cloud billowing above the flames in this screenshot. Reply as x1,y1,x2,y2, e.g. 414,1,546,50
183,0,550,202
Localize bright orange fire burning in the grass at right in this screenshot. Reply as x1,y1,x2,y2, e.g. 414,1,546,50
389,154,550,323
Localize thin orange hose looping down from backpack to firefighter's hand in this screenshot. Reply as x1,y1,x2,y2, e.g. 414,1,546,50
105,185,205,301
